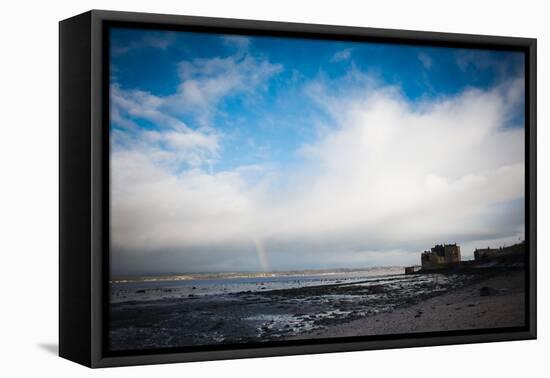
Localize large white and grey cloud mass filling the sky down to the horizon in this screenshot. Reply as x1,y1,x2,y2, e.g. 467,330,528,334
111,64,525,274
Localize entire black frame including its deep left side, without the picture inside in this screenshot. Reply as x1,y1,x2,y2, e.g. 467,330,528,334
59,10,537,368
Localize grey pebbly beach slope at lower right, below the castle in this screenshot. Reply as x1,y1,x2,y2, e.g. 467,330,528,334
288,270,525,340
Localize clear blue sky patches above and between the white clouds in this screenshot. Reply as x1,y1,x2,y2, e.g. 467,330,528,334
111,29,523,176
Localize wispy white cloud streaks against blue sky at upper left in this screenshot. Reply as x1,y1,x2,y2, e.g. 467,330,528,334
111,36,283,128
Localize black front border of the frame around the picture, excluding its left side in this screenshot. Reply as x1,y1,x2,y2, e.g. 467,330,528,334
80,10,536,367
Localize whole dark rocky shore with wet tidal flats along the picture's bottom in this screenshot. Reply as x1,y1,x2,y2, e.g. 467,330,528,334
109,269,525,351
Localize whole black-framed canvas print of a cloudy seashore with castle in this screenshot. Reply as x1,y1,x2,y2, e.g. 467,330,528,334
59,11,536,367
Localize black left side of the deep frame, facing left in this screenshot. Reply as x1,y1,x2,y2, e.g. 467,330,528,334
59,12,93,366
